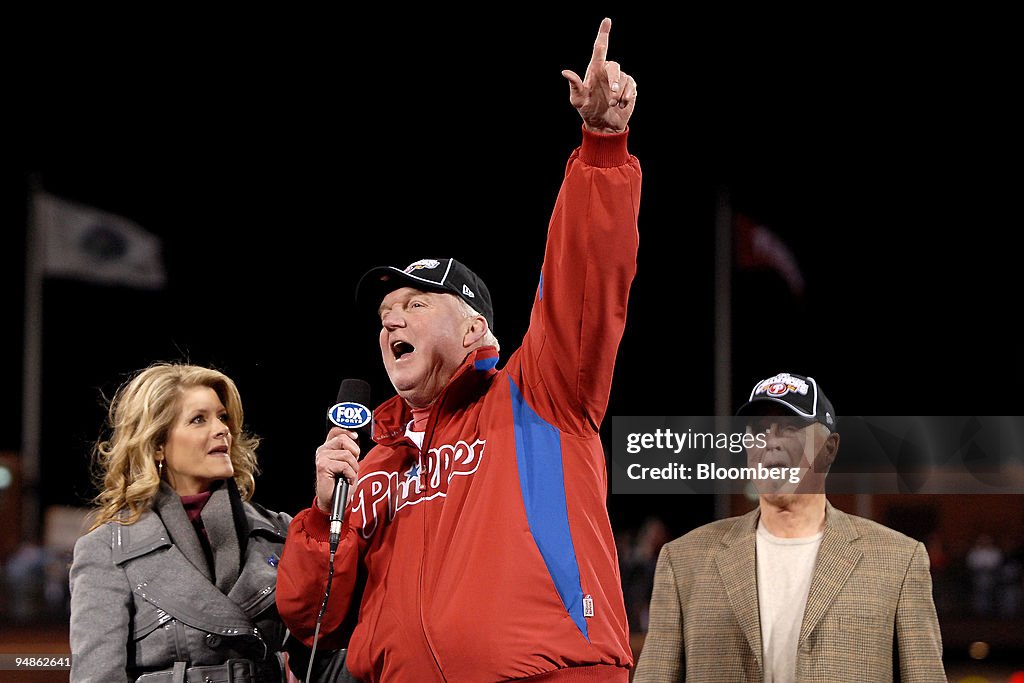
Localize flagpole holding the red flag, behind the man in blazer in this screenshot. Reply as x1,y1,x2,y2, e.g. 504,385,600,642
715,185,732,519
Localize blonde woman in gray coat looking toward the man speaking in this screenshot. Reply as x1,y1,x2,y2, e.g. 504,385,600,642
71,362,308,683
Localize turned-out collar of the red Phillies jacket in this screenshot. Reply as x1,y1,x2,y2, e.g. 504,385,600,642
373,346,499,445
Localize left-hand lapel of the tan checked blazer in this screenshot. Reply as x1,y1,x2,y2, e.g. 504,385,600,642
715,509,764,670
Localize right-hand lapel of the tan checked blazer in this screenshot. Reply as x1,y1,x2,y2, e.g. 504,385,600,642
799,502,863,643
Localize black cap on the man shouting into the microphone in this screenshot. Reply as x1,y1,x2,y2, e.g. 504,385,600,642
355,258,495,330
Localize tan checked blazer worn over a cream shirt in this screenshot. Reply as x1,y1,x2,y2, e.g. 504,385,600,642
634,504,947,683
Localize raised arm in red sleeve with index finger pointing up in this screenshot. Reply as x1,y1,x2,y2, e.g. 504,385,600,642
508,19,641,435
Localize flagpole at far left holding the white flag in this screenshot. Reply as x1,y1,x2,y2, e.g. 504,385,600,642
22,179,43,541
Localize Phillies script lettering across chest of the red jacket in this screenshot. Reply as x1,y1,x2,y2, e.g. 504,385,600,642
351,439,486,539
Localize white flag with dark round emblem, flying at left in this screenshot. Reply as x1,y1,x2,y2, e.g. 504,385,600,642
35,191,167,289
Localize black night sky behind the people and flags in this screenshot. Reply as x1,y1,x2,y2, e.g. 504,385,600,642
0,9,1022,530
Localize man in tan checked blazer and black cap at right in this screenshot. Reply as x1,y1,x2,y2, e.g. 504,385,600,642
633,373,947,683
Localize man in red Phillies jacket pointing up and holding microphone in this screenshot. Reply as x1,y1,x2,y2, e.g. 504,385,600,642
278,18,641,683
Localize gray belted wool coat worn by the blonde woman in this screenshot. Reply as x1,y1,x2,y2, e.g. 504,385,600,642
70,484,301,683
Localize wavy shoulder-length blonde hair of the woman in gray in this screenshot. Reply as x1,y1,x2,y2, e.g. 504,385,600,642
90,362,259,529
